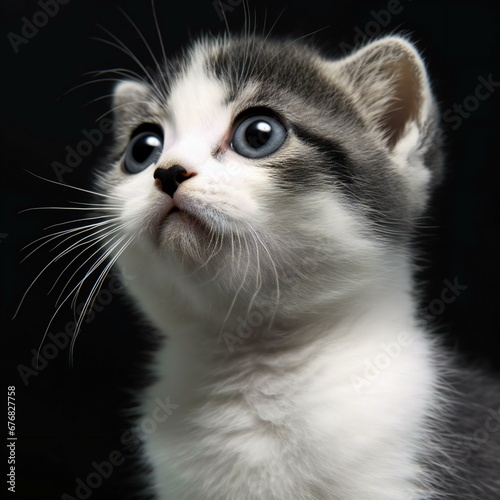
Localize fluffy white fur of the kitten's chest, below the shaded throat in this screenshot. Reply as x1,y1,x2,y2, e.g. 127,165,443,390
126,260,434,500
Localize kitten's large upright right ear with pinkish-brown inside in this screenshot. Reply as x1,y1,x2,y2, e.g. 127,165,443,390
329,37,440,150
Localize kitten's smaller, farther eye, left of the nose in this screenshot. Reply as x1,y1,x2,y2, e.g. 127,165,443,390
124,126,163,174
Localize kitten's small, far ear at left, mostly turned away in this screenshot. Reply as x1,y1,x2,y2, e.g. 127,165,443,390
113,80,150,128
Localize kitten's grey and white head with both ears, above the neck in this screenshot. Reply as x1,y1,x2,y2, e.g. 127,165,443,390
100,37,441,324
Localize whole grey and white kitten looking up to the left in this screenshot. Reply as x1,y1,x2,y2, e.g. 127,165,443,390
95,33,500,500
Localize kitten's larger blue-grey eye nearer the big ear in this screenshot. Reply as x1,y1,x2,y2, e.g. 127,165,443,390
231,115,287,158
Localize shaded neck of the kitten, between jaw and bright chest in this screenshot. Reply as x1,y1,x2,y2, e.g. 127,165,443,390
124,240,415,338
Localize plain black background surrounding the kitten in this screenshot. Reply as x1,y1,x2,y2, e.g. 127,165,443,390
0,0,500,499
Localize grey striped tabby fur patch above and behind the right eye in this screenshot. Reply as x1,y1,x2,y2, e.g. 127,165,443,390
203,38,418,239
